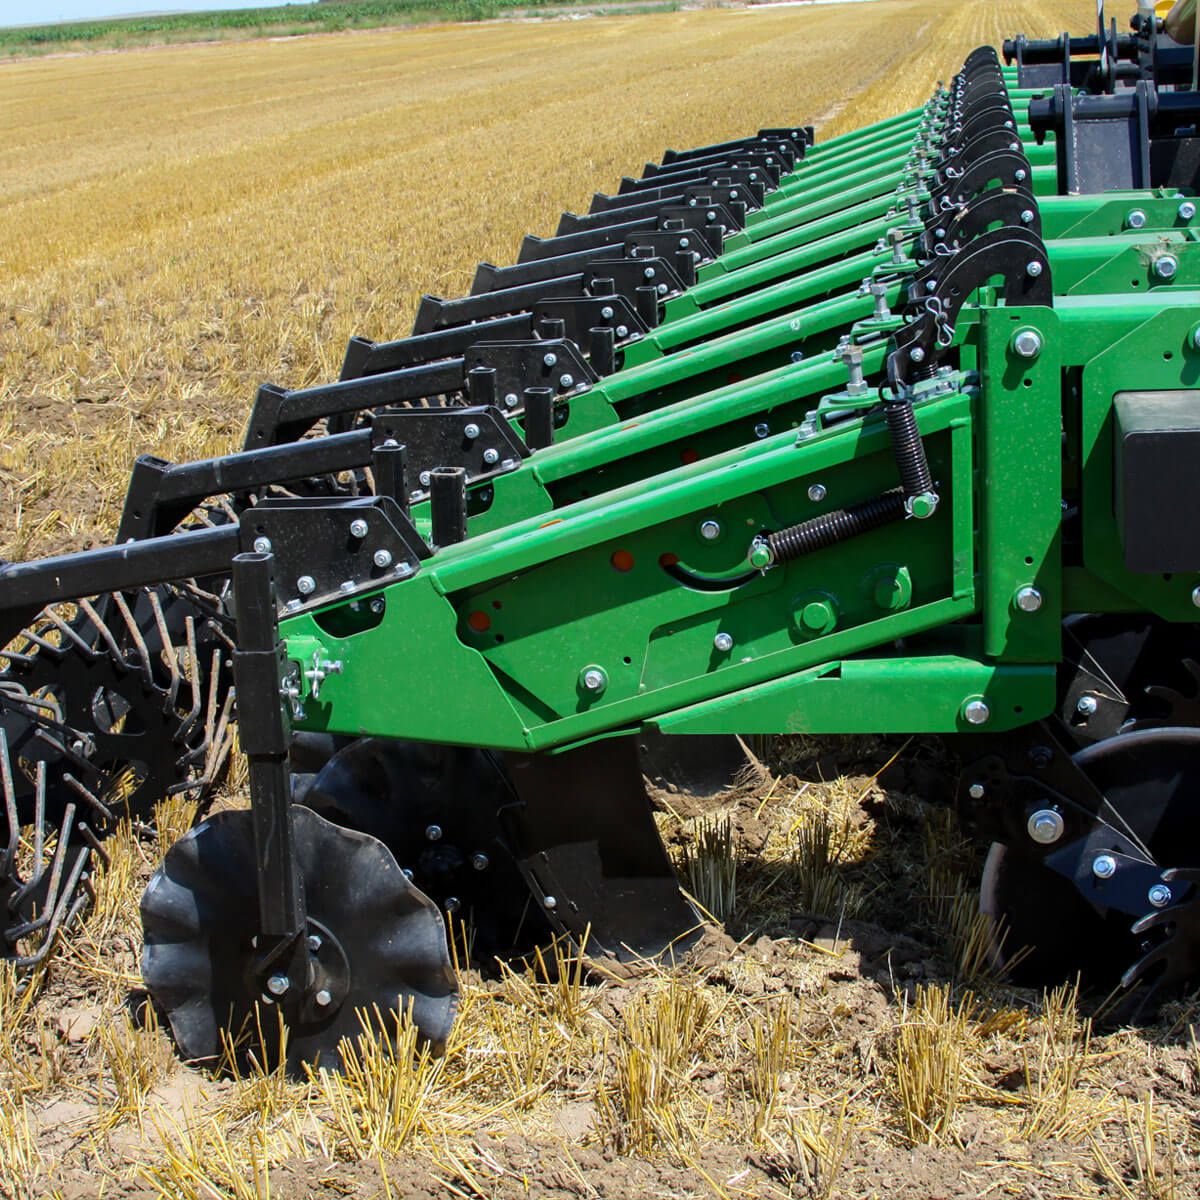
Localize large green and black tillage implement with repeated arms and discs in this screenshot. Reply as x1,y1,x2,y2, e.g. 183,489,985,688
7,5,1200,1069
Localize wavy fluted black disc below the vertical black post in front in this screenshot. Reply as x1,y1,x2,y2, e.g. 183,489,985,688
142,805,457,1070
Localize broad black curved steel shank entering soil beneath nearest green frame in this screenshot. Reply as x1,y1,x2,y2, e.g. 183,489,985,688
505,737,701,961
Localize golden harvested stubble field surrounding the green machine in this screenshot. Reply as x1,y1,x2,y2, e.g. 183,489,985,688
9,0,1200,1200
